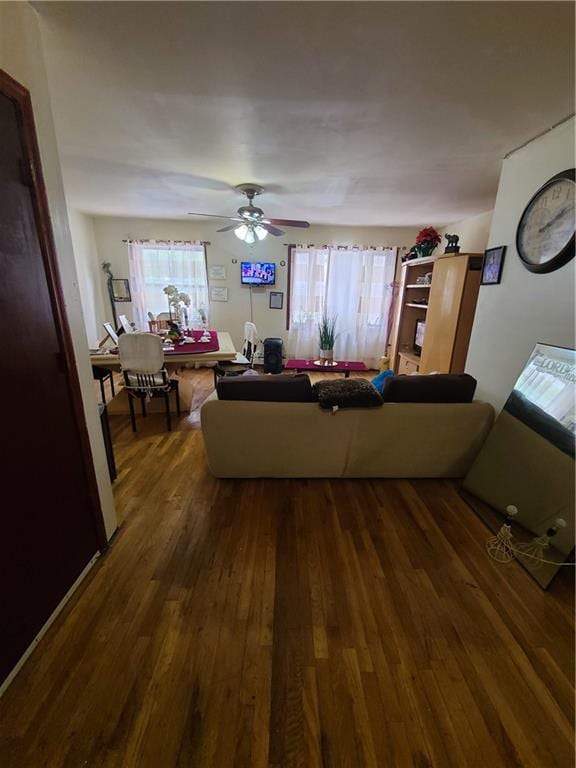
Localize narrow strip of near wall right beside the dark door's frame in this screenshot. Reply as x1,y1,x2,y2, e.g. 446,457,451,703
0,3,117,536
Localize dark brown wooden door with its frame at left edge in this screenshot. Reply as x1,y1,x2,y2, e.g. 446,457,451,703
0,72,102,681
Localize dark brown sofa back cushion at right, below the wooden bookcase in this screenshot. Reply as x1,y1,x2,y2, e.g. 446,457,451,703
382,373,476,403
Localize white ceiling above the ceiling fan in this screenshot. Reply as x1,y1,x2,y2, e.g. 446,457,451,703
36,2,574,226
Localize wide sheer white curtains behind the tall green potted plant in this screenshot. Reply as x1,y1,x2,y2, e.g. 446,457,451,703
288,248,397,368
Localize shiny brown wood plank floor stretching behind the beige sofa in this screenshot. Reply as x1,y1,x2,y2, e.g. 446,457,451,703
0,370,574,768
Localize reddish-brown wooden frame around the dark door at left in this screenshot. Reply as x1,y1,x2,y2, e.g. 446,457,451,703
0,69,108,553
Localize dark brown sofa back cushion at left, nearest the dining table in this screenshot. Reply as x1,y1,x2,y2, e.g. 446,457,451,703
216,373,316,403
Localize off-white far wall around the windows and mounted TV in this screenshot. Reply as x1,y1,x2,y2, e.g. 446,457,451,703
94,217,418,348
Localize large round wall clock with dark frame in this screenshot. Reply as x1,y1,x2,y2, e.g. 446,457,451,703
516,168,576,272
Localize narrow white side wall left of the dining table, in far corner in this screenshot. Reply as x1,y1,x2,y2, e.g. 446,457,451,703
68,208,108,347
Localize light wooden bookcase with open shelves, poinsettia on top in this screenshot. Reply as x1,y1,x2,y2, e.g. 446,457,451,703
390,253,483,373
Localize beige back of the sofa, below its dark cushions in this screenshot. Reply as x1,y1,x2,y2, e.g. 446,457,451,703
201,395,494,477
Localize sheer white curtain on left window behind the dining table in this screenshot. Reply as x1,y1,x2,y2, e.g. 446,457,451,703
128,241,209,330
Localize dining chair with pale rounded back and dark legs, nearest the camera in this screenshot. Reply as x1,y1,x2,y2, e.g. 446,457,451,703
118,333,180,432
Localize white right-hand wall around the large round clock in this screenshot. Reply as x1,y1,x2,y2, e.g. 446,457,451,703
466,118,575,408
